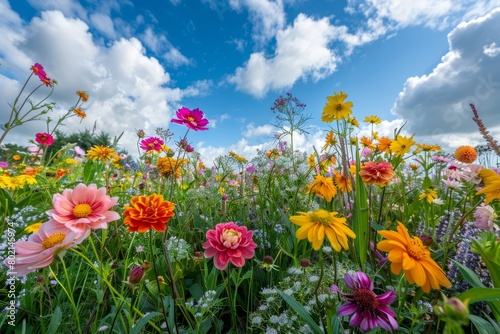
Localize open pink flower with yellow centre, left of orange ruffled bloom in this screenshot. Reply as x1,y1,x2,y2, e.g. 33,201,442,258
47,183,120,232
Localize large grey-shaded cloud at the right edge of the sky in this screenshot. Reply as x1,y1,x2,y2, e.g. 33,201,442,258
392,8,500,147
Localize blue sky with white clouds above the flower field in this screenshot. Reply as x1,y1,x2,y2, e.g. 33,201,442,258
0,0,500,164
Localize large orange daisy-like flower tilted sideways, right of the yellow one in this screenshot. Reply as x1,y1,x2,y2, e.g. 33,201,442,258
377,222,451,292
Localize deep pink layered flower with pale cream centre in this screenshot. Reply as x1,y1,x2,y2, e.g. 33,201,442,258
203,222,257,270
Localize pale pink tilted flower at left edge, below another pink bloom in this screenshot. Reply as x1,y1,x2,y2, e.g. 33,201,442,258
4,221,90,276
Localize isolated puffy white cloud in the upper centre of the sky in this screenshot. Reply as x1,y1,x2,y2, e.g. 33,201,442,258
228,14,339,97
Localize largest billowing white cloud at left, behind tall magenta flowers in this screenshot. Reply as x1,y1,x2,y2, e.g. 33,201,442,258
0,6,198,153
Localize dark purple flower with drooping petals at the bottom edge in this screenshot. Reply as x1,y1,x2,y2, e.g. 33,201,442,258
331,271,398,333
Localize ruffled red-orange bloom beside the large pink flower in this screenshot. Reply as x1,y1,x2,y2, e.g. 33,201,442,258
123,194,175,233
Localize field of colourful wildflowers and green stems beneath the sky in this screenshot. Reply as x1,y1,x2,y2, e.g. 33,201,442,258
0,64,500,334
